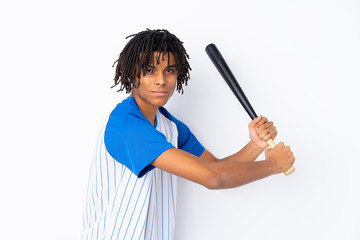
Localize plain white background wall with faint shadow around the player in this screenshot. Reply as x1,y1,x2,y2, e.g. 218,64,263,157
0,0,360,240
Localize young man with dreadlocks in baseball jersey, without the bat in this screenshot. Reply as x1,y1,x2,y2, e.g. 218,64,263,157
82,30,295,239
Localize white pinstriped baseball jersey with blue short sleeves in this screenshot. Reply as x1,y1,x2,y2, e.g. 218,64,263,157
81,97,204,239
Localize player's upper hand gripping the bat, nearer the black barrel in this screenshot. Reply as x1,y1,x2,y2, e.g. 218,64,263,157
248,115,277,150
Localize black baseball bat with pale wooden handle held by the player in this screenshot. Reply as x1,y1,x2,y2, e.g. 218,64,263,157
205,43,295,175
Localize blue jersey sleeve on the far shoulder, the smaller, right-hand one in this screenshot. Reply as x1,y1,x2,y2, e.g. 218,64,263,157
160,107,205,157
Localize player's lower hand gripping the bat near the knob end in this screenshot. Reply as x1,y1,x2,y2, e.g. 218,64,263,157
265,142,295,173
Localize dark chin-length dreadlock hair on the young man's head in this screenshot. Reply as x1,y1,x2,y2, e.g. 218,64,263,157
111,29,191,94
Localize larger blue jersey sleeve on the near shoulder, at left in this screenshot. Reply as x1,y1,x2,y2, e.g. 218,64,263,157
104,107,174,177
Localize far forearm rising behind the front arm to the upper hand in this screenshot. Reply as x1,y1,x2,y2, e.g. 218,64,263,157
221,141,264,162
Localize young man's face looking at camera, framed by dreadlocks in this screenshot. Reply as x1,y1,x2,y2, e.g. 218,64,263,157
131,52,177,108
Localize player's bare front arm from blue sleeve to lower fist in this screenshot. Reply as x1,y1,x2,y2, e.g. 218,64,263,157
151,143,295,189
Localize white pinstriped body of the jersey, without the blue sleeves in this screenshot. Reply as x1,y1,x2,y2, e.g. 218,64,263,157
81,112,178,240
